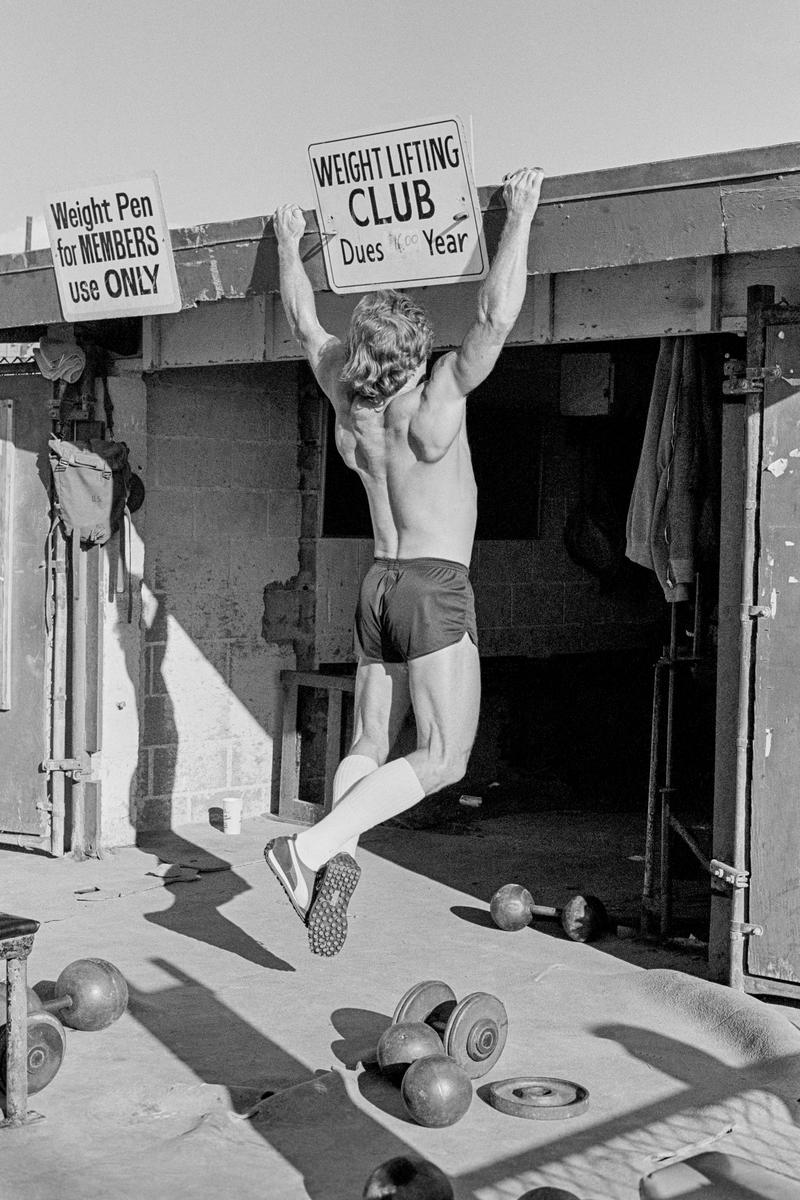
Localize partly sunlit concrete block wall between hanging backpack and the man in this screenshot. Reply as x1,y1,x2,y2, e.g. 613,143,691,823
134,364,302,829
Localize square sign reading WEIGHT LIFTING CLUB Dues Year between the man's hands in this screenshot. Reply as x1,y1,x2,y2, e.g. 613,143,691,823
308,118,488,294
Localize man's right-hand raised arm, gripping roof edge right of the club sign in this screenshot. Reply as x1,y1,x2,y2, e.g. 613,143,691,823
443,167,545,396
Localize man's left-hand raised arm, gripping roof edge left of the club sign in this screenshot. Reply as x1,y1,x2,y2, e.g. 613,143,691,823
272,204,343,401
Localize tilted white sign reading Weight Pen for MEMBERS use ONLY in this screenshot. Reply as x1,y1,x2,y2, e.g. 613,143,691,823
44,173,181,322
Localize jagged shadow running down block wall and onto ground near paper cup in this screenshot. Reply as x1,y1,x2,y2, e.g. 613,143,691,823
126,596,294,971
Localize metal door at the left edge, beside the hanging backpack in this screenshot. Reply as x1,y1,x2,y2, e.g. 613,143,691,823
0,368,50,847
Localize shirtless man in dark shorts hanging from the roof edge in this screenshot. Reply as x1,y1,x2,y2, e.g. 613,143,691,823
264,168,542,954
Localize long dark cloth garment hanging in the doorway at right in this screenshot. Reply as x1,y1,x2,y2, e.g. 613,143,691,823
626,337,716,602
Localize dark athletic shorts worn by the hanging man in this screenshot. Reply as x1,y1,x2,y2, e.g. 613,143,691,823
355,558,477,662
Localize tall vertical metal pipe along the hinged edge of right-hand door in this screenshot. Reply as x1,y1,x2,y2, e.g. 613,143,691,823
728,287,775,991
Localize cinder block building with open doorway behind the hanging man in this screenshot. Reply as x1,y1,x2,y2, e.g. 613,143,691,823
0,145,800,995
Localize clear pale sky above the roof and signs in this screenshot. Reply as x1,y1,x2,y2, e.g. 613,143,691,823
0,0,800,253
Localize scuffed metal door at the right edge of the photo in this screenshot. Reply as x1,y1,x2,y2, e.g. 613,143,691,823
746,313,800,984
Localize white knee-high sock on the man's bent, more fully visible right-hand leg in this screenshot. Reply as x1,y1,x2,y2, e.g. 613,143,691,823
295,758,425,871
